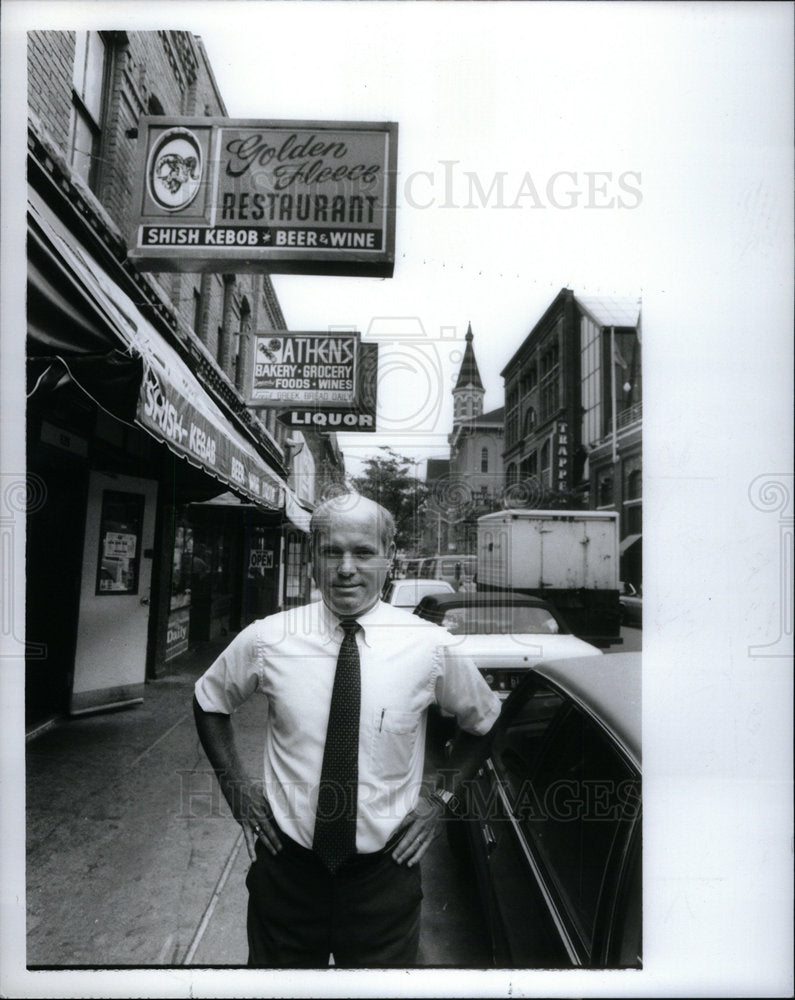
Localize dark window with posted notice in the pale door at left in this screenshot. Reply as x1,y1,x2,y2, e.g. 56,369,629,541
96,490,144,596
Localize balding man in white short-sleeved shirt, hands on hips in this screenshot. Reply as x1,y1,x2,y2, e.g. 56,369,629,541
194,494,500,967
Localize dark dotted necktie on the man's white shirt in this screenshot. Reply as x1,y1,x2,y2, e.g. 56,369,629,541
312,620,361,874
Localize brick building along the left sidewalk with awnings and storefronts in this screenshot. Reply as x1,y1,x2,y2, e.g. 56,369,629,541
26,31,342,723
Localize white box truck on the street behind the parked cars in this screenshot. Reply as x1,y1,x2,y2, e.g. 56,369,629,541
477,509,621,647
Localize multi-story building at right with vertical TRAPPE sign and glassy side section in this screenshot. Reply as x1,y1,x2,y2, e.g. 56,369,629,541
502,288,642,582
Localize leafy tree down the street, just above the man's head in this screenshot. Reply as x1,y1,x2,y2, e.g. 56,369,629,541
351,445,428,552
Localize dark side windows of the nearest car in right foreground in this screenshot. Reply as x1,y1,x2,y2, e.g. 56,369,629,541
492,684,640,954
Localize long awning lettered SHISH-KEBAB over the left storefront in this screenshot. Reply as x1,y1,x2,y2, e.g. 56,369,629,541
28,190,286,509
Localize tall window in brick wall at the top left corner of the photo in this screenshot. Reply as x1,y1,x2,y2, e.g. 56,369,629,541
69,31,107,190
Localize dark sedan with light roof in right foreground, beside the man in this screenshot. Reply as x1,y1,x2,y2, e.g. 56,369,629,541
447,653,642,969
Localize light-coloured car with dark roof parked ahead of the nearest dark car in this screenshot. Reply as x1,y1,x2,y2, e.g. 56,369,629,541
414,591,600,698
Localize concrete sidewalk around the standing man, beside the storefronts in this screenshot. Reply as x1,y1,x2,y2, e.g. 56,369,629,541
26,637,483,967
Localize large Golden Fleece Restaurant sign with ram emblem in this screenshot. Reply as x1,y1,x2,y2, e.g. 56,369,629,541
129,116,397,277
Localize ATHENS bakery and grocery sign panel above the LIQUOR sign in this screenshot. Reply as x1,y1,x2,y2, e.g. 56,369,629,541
246,331,359,407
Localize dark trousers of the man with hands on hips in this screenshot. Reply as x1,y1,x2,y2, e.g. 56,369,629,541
246,834,422,968
